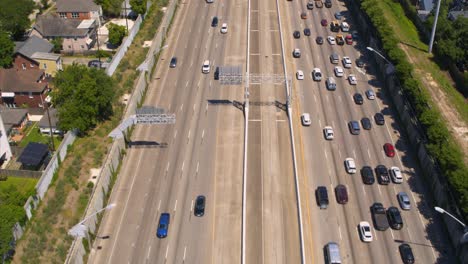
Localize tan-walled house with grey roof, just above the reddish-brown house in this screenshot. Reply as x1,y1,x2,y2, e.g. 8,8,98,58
13,36,62,76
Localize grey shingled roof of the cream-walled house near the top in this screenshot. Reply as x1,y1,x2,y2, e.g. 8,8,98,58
34,16,88,37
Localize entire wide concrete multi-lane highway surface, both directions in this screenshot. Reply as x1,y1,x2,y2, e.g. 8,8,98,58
89,0,454,263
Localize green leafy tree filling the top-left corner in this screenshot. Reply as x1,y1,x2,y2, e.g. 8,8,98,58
0,0,35,40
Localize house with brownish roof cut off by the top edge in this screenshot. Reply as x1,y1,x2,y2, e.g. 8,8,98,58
56,0,102,25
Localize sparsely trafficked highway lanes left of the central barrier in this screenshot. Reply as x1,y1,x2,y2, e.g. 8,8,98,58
89,1,245,263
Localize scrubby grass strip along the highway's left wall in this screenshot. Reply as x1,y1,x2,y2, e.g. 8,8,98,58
13,0,172,263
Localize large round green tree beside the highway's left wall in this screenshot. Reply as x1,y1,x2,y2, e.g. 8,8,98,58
52,64,115,133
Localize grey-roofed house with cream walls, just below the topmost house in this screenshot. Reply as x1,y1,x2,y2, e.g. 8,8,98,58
31,15,97,53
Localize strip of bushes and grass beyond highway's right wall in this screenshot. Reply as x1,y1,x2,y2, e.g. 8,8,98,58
361,0,468,219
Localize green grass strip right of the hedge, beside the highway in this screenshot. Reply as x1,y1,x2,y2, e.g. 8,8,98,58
379,0,468,123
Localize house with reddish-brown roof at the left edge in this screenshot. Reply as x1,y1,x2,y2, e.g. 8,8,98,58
0,68,49,108
